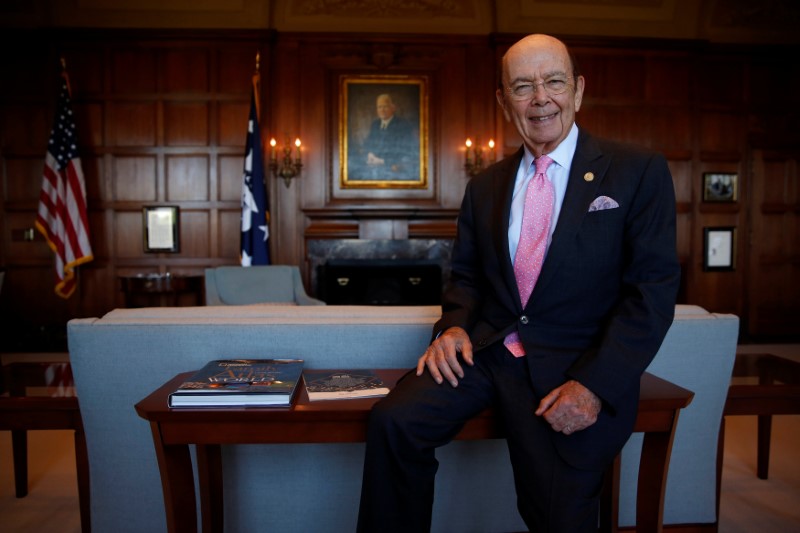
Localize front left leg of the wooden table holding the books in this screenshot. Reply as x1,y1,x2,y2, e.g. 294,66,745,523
150,422,197,533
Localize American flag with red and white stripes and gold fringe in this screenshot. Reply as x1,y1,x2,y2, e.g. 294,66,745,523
34,71,93,298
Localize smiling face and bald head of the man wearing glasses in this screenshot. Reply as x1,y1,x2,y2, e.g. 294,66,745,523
497,35,584,157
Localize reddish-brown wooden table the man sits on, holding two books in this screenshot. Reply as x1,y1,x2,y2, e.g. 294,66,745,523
136,370,694,533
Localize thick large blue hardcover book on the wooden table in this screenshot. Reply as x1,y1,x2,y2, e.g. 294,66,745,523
169,359,303,407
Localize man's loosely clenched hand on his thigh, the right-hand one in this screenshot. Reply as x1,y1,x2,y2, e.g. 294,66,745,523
536,380,602,435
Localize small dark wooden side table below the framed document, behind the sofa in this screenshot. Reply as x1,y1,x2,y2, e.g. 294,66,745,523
119,272,205,307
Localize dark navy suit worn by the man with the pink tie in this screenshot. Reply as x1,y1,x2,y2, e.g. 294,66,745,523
359,130,680,531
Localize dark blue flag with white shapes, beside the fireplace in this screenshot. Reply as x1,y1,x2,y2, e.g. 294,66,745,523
241,75,270,266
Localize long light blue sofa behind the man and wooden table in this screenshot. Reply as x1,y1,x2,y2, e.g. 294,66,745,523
68,305,738,533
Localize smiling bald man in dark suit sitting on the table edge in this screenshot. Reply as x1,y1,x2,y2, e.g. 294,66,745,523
359,35,680,533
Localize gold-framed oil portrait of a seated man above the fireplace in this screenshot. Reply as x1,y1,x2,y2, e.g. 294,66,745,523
339,75,428,189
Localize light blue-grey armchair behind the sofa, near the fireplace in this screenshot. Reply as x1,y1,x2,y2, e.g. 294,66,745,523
205,265,325,305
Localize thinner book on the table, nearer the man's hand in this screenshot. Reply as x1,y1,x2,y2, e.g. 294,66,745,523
303,370,389,402
